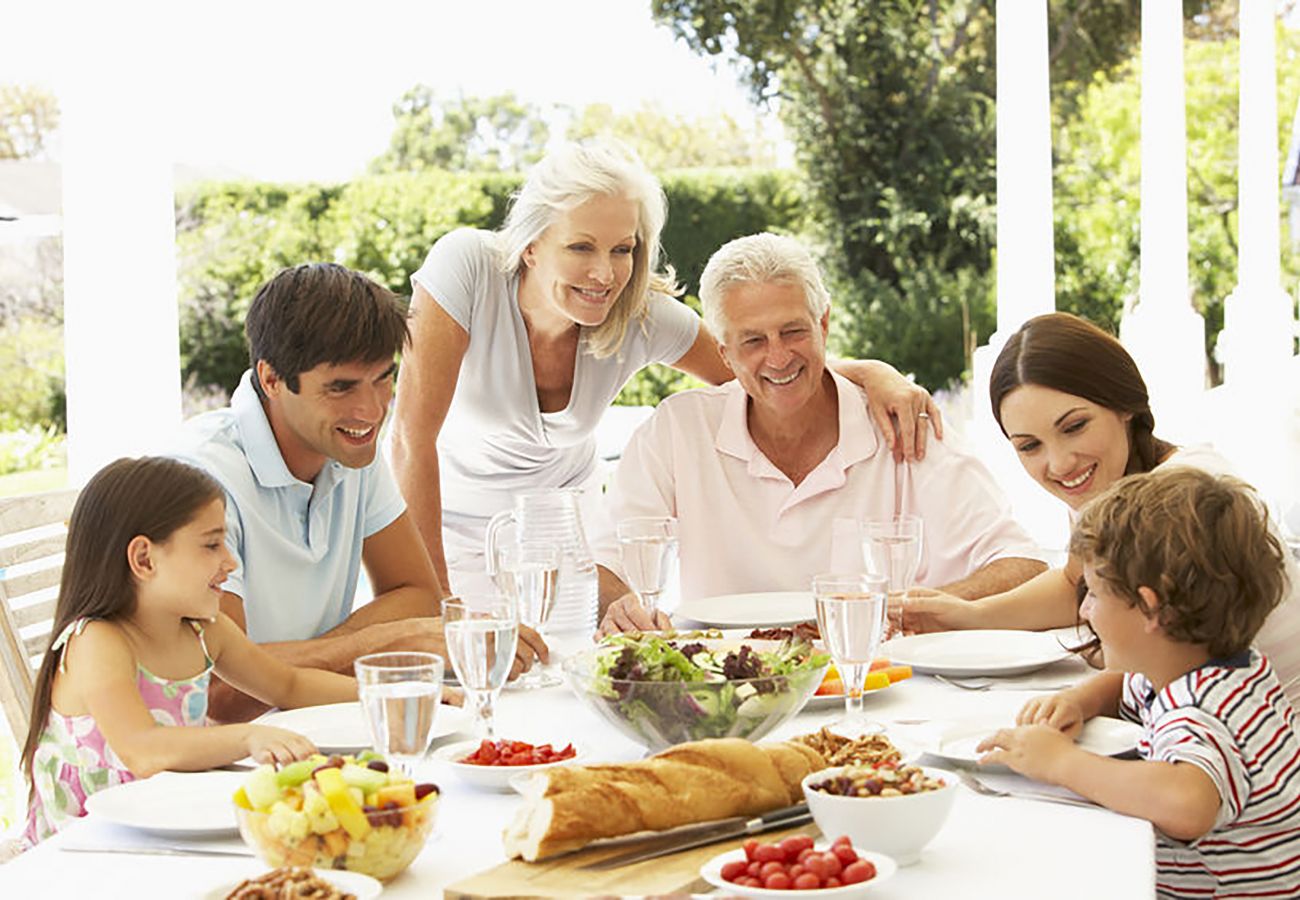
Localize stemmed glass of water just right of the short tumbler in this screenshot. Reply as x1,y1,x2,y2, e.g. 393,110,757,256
442,594,519,740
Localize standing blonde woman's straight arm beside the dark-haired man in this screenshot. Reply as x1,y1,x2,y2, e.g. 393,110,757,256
393,285,469,587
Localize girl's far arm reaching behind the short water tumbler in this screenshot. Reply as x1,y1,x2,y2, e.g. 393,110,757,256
203,613,356,709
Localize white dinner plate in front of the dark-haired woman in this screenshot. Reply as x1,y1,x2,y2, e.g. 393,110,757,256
880,629,1070,678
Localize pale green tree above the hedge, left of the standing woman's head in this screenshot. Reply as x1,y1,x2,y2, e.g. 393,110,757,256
371,85,547,172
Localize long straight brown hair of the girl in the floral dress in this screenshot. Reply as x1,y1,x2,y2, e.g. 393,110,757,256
22,457,224,791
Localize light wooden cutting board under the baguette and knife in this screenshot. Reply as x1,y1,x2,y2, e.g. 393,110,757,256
443,822,822,900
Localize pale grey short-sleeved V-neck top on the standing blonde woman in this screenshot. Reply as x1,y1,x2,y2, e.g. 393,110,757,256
410,229,699,580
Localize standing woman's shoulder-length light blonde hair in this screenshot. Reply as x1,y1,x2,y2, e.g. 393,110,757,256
497,139,680,358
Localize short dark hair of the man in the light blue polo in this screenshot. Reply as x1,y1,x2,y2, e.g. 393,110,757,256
244,263,408,398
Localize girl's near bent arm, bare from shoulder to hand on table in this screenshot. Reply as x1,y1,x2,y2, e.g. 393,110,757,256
64,622,316,778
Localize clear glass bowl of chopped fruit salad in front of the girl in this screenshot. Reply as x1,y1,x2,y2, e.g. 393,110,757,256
234,752,439,880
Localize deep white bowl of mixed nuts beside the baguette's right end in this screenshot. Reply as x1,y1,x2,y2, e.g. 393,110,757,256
803,762,957,866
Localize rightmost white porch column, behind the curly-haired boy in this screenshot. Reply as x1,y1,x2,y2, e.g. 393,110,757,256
1219,0,1297,517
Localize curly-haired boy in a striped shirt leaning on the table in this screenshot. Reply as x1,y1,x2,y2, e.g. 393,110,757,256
980,468,1300,897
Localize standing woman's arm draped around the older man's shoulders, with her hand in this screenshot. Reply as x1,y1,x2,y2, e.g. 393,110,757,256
671,323,944,462
